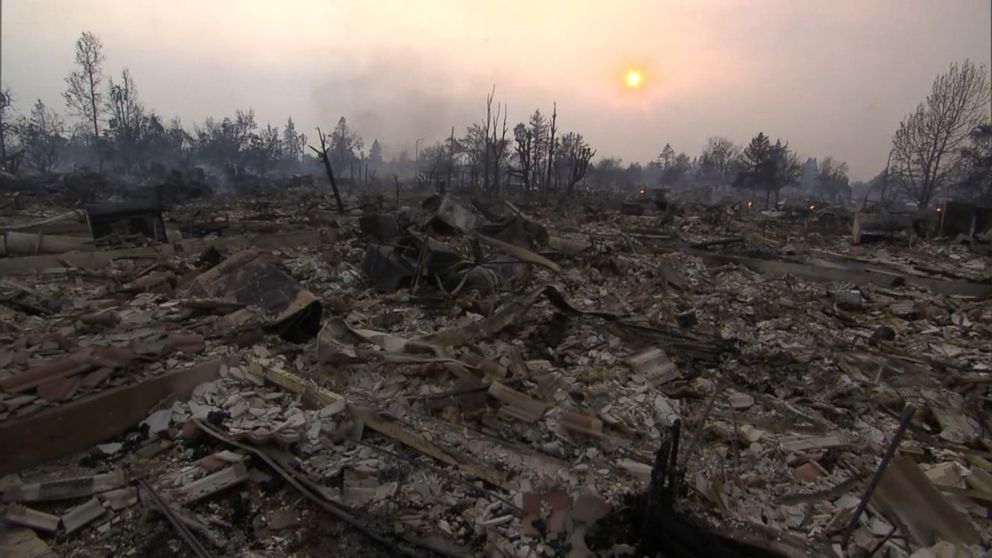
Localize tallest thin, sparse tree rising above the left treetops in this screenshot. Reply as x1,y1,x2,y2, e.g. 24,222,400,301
62,31,104,170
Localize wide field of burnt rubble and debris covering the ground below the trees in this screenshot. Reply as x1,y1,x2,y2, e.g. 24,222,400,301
0,186,992,558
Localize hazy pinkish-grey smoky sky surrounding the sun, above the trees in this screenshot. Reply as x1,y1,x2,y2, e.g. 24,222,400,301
0,0,992,179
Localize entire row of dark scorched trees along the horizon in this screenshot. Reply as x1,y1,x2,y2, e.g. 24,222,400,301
0,32,992,208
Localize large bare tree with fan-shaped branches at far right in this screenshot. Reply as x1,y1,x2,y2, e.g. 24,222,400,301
891,60,990,209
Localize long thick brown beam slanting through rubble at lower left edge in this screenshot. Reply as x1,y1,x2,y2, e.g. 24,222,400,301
0,360,221,475
